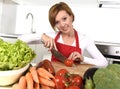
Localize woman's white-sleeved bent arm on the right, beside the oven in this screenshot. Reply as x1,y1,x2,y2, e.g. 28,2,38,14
80,36,108,66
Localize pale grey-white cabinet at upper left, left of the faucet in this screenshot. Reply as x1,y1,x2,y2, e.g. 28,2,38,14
0,0,17,34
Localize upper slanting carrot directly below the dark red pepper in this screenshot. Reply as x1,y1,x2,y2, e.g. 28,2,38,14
37,67,55,80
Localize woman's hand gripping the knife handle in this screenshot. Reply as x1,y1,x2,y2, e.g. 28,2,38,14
41,34,57,50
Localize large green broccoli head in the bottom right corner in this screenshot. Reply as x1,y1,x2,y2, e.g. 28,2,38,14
93,64,120,89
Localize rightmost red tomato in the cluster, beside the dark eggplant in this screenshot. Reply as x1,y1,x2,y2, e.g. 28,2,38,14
69,74,83,87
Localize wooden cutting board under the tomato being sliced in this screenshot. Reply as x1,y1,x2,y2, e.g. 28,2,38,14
52,62,94,77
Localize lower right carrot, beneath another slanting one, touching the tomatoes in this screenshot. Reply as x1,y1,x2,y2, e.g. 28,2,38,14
39,77,55,87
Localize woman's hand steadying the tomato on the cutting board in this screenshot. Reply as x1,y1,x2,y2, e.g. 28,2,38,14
68,51,84,62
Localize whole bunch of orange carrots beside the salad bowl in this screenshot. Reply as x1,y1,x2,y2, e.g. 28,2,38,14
12,66,55,89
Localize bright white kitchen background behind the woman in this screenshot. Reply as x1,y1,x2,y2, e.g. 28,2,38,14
0,0,120,62
